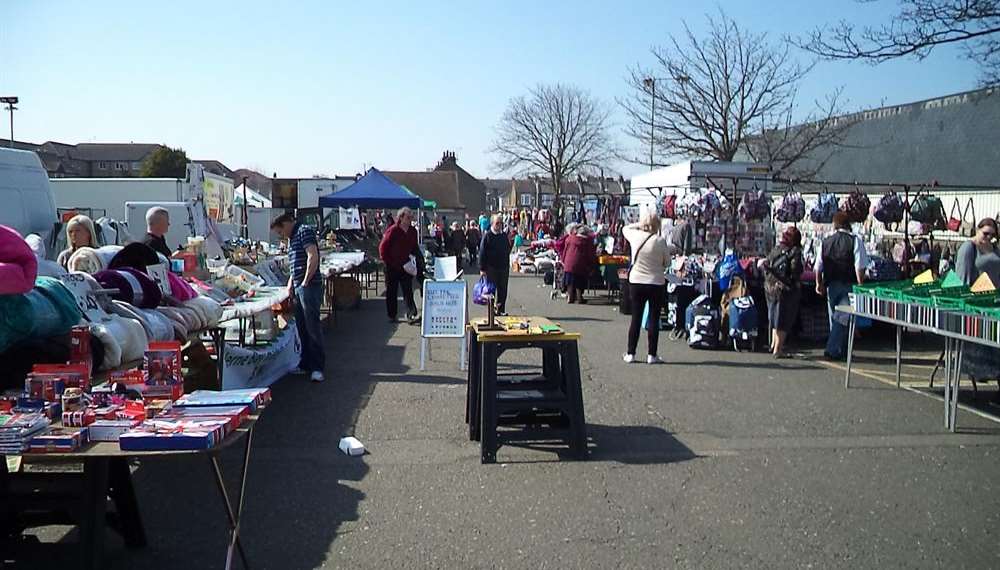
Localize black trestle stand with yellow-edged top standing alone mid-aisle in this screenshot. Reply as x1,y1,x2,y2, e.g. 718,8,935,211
465,317,587,464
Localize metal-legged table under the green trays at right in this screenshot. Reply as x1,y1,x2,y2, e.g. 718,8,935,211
836,296,1000,432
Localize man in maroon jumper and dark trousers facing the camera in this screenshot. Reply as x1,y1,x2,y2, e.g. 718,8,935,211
378,208,420,324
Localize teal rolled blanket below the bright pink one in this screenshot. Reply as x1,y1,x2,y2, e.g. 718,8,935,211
0,276,82,352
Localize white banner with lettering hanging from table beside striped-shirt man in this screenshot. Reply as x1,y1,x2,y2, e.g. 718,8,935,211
222,326,302,390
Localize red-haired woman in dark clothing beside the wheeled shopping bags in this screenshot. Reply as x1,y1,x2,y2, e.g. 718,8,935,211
763,226,802,358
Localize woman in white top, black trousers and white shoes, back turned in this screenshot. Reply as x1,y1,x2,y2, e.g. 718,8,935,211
622,210,673,364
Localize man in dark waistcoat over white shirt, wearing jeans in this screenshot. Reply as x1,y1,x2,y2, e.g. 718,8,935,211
814,211,868,360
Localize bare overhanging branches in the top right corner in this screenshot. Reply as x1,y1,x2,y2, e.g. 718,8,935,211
793,0,1000,85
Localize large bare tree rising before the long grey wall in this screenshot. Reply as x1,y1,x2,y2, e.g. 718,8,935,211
619,14,849,175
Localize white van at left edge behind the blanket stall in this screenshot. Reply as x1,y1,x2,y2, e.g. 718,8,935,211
0,148,58,243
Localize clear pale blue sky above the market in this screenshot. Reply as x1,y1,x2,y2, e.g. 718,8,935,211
0,0,977,177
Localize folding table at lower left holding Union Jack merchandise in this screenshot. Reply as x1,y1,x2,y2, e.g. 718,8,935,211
0,408,263,570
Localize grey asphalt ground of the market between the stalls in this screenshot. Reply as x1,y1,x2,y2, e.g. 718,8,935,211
4,277,1000,569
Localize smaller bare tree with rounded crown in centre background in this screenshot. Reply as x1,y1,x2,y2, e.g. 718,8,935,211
491,84,616,206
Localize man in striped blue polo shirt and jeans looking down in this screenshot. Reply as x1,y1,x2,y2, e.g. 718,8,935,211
271,214,326,382
